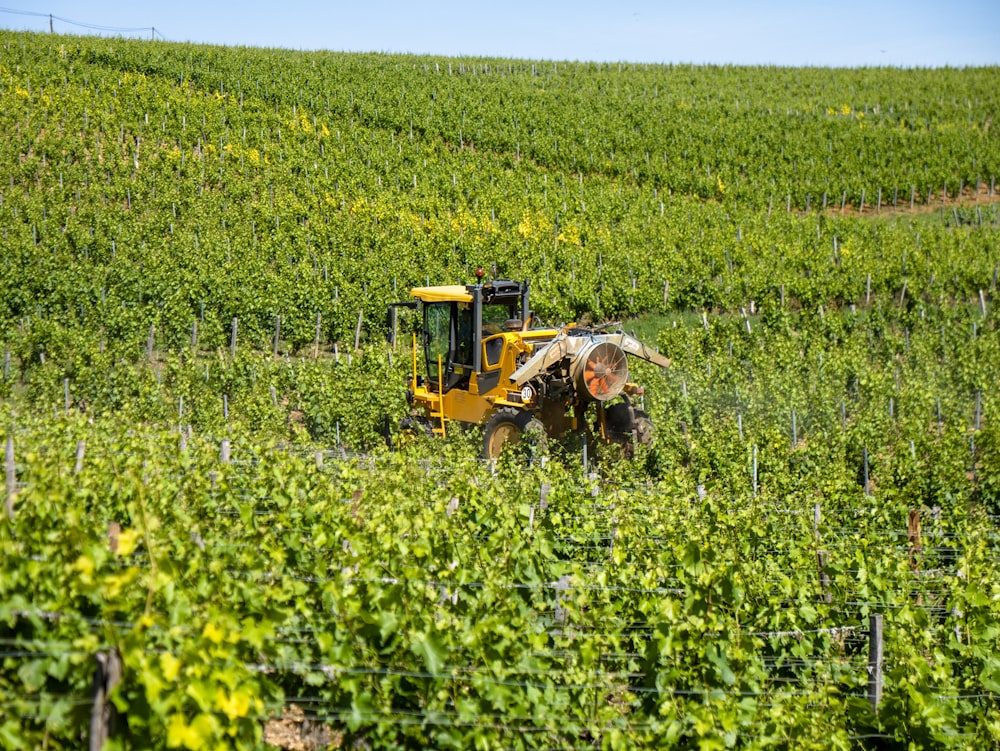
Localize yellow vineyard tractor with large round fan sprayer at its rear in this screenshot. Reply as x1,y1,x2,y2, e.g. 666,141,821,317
389,272,670,458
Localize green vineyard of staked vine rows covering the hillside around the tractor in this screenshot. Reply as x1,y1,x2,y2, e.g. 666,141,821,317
0,26,1000,750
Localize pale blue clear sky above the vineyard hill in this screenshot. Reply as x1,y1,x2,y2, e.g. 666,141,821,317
0,0,1000,67
